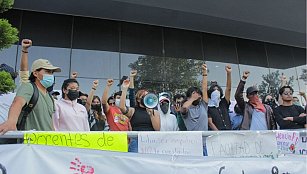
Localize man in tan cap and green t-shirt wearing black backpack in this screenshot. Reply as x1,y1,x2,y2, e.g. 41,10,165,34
0,59,61,134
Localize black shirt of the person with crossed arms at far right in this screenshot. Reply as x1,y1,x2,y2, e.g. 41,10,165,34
274,105,306,129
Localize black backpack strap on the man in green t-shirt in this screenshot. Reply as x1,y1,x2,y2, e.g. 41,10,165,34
17,82,39,130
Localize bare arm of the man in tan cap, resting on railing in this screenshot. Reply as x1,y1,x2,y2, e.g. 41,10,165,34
0,96,26,134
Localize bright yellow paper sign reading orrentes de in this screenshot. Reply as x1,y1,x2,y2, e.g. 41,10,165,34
24,132,128,152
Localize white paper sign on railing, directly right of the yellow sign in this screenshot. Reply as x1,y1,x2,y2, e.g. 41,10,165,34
138,132,203,156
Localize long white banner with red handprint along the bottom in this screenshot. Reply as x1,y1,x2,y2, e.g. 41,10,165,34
0,144,307,174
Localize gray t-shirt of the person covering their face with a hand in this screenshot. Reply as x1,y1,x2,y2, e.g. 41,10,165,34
183,100,208,131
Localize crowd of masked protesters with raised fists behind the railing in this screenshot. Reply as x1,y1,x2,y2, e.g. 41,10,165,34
0,39,307,152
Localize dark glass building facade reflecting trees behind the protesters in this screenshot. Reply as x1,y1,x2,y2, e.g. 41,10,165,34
0,10,307,103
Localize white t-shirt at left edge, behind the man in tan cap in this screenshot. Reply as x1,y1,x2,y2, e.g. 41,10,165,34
0,92,16,124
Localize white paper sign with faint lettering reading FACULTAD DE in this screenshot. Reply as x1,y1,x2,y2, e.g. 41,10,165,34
206,132,278,158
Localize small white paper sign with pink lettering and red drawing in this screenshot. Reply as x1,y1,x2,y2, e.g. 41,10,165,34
276,131,300,154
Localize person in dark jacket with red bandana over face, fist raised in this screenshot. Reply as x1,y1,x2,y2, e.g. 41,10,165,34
235,71,277,130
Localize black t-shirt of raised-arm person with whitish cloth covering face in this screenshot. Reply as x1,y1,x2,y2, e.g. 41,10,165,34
208,98,231,130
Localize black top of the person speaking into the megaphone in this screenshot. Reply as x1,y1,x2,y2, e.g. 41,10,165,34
130,107,154,131
